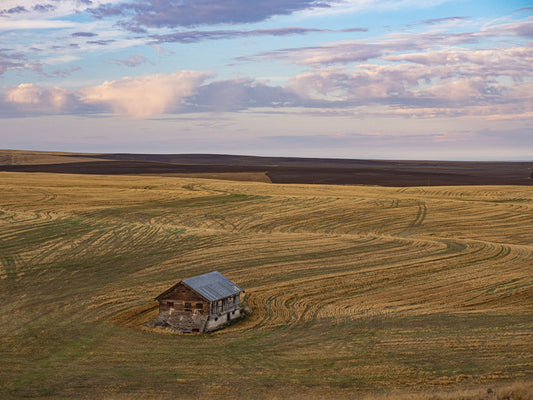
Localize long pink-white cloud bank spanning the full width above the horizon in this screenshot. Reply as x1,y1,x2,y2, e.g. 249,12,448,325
2,47,533,120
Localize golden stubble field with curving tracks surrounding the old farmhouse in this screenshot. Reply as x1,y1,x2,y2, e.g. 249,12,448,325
0,173,533,399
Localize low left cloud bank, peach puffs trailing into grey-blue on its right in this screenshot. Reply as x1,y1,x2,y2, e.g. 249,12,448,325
0,71,305,119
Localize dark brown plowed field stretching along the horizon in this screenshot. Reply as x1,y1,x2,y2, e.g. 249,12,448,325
0,154,533,186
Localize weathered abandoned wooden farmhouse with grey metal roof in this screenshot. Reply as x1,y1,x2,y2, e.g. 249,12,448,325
155,271,244,333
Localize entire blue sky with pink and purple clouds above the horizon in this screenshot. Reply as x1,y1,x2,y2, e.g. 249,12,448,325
0,0,533,161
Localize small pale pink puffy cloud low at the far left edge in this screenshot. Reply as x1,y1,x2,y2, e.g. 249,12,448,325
5,83,71,112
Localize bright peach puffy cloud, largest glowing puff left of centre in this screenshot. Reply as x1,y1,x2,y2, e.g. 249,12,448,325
78,71,212,118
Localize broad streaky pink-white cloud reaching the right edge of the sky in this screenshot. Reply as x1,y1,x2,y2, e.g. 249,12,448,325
289,41,533,112
